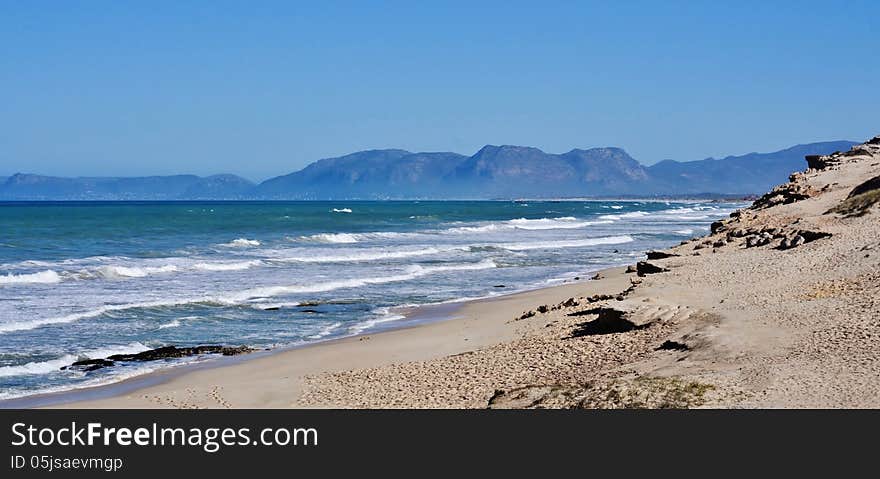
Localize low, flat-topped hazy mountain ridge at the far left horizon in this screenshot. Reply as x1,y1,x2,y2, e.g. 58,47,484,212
0,173,254,201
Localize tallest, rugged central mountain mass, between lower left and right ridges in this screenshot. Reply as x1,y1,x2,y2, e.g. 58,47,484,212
252,145,648,199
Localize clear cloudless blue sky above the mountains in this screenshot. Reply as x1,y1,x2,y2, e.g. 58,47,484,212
0,0,880,179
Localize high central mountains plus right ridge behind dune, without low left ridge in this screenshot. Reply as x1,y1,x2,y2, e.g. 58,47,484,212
251,141,855,200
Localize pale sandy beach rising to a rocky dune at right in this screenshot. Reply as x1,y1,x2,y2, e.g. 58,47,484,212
20,138,880,408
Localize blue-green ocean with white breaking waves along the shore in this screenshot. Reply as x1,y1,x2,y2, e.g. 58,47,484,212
0,201,743,399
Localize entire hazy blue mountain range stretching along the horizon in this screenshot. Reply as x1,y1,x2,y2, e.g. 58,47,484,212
0,141,856,201
